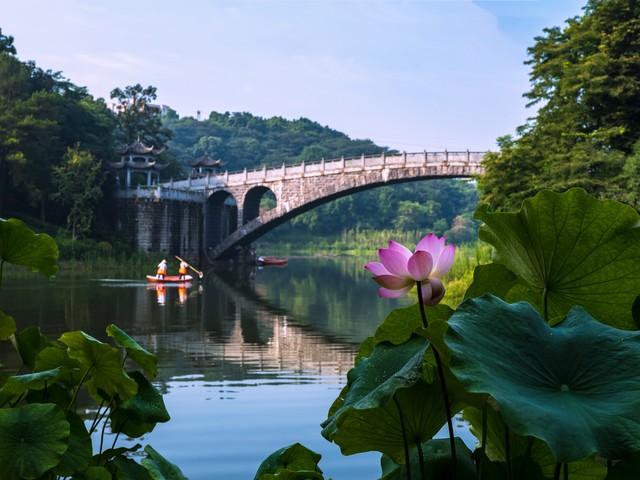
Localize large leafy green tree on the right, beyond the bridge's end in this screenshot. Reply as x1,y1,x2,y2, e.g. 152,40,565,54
480,0,640,209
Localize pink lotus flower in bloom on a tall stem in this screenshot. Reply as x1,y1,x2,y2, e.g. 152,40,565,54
364,233,456,305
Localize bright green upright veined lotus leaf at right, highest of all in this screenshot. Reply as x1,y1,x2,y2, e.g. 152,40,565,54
476,189,640,329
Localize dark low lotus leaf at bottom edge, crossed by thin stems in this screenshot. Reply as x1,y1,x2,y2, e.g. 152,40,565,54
380,437,476,480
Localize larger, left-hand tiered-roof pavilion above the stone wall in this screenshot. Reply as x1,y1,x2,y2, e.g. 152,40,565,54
109,139,167,188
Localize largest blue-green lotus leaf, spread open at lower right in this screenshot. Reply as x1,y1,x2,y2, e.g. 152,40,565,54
445,295,640,462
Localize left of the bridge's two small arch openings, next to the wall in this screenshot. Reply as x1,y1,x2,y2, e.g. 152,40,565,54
204,190,238,248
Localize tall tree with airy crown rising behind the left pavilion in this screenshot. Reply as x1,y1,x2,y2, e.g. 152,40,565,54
111,83,172,148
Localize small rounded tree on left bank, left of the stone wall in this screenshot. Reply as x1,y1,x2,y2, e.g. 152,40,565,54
52,145,103,244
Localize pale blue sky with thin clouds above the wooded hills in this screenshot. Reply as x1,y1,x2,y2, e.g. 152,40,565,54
0,0,585,151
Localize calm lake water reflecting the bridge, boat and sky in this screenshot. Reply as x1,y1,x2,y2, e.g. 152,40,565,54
0,258,474,480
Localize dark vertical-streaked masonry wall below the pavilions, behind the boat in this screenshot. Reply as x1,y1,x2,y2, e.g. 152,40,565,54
115,198,204,262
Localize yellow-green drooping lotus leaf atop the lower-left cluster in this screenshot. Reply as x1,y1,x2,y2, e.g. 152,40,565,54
60,330,138,400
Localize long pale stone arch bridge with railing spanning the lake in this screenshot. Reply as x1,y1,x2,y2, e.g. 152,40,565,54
119,151,486,262
